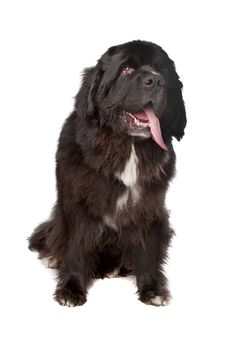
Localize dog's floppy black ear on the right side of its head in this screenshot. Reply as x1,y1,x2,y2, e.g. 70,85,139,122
171,82,187,141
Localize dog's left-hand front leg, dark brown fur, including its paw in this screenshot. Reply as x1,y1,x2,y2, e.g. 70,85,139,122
54,210,101,306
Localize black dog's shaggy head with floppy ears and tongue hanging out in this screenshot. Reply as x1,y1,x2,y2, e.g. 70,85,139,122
76,41,186,150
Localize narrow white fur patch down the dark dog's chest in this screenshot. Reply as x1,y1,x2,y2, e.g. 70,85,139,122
104,145,141,229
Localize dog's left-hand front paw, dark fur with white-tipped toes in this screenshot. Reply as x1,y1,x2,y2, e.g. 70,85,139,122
54,288,87,307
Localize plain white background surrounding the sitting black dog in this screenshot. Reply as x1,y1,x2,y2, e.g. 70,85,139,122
0,0,233,350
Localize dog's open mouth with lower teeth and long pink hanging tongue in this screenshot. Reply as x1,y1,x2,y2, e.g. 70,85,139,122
122,104,168,151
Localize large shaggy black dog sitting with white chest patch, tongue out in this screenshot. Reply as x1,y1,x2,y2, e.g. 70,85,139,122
29,41,186,306
